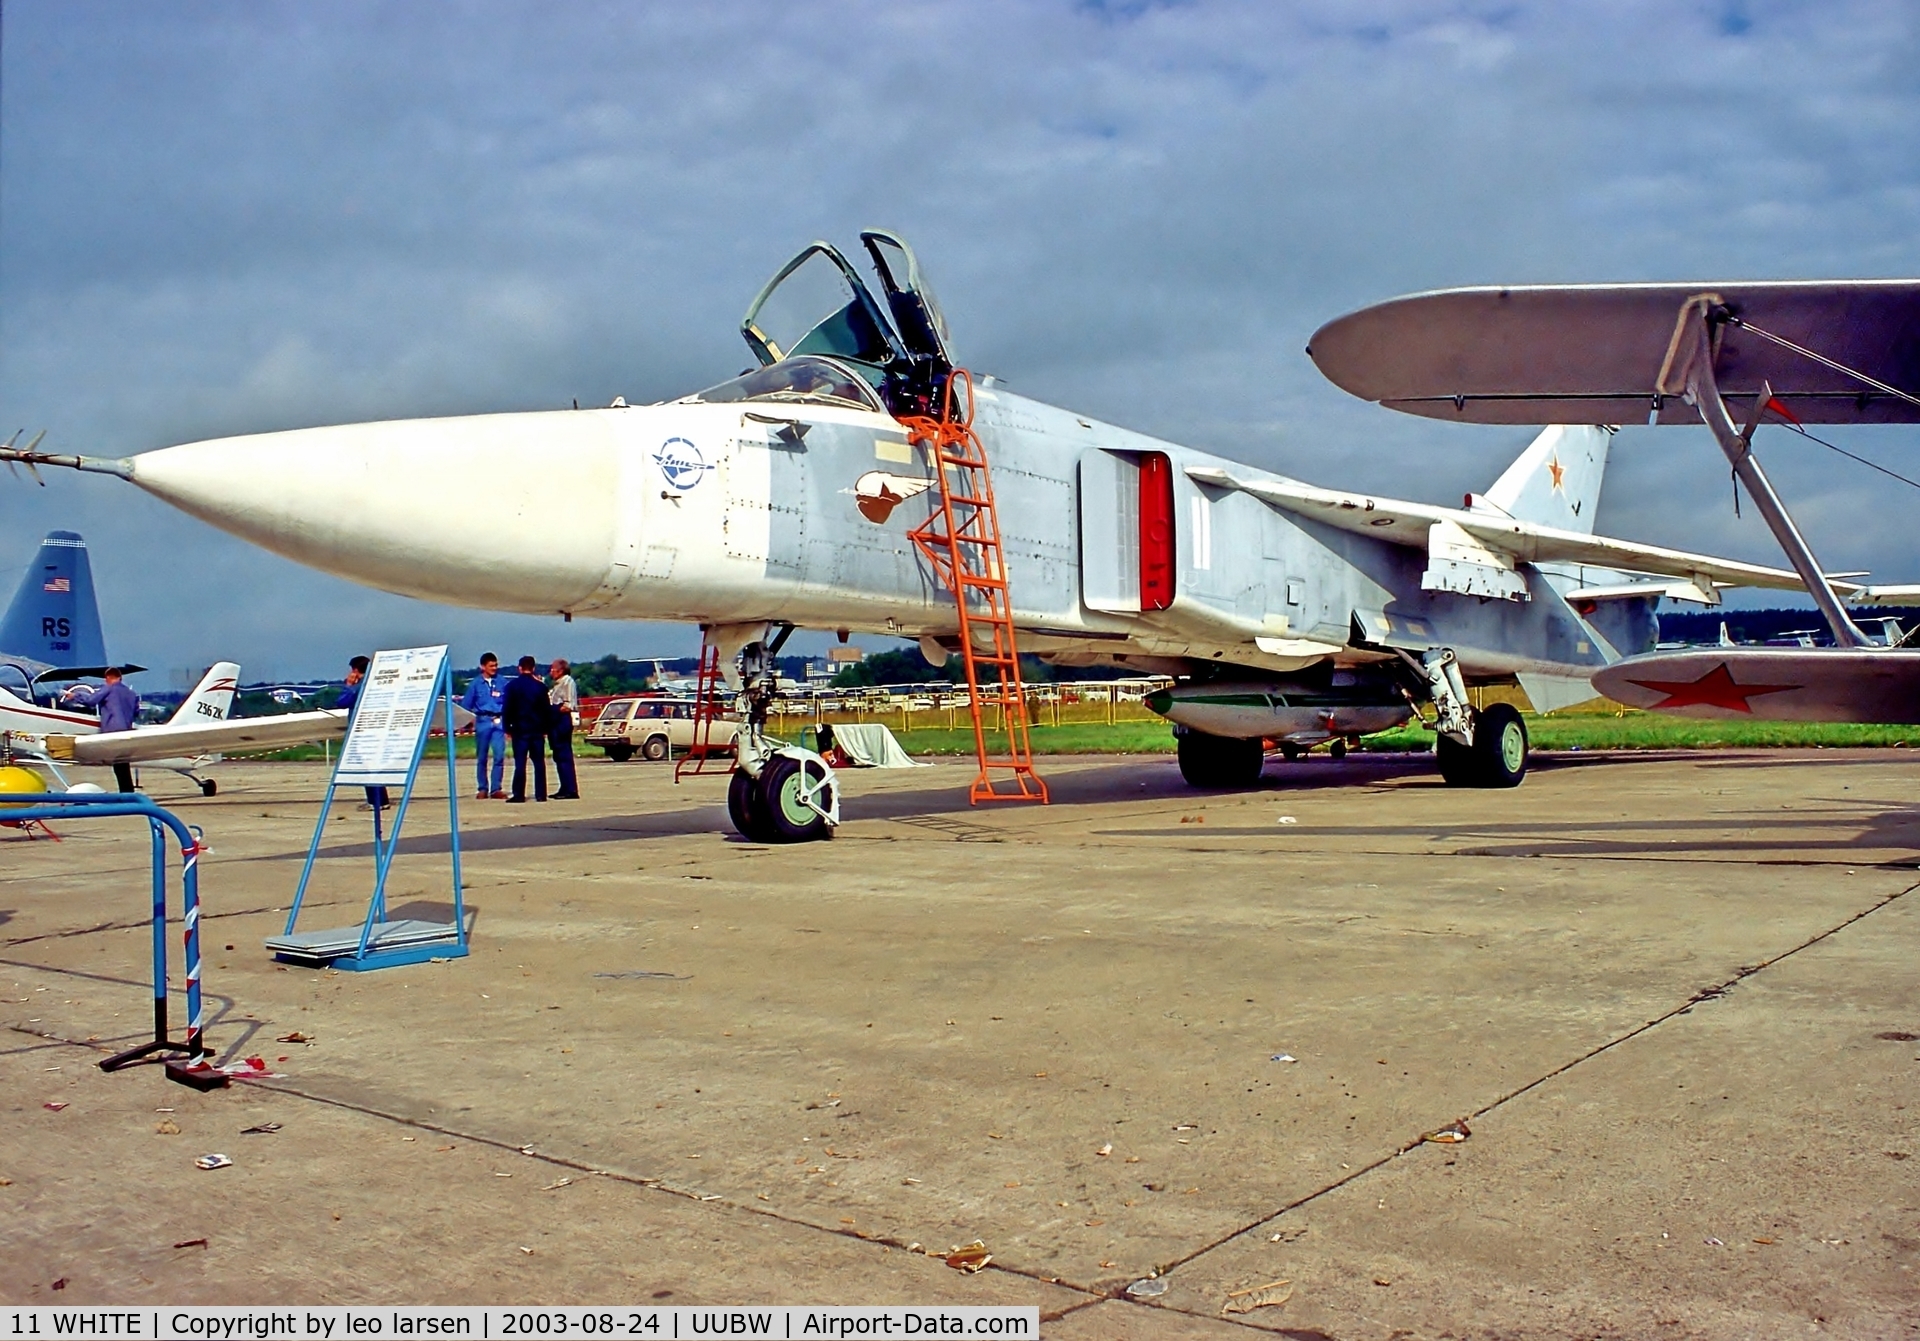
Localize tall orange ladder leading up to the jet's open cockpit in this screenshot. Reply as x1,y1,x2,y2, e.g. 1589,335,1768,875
900,369,1046,805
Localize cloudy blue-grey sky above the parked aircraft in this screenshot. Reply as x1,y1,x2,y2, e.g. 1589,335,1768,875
0,0,1920,688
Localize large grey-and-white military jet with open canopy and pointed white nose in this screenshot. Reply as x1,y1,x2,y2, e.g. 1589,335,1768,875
0,231,1881,836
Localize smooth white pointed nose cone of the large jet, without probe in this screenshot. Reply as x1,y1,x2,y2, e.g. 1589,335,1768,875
132,411,636,613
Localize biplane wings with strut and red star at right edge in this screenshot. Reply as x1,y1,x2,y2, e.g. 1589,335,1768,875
1309,279,1920,722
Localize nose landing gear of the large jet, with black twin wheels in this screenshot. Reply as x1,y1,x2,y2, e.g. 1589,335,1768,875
726,624,839,843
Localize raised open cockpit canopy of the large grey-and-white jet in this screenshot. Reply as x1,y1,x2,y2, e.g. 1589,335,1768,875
741,229,952,415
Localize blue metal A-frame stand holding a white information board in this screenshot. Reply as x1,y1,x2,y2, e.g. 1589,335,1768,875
267,647,467,972
